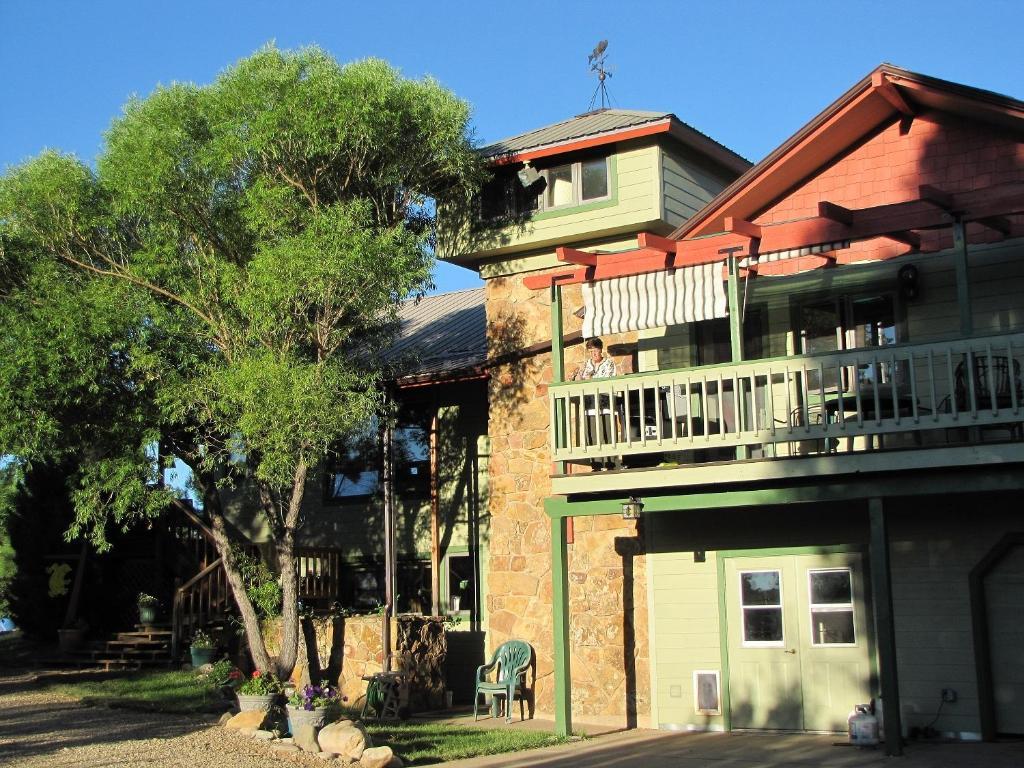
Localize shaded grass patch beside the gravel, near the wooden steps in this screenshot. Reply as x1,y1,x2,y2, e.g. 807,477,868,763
42,672,223,713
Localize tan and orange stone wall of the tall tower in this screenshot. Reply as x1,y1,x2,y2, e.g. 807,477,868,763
486,275,650,725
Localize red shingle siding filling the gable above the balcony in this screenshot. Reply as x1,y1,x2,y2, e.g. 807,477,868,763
755,116,1024,264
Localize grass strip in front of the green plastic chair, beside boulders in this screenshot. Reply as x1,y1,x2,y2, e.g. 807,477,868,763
367,723,567,765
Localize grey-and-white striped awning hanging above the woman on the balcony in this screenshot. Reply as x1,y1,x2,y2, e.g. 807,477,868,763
583,261,729,338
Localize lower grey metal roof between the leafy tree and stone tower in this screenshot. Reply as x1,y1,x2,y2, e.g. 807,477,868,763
385,288,487,379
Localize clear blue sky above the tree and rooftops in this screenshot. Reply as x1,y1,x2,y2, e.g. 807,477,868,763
0,0,1024,290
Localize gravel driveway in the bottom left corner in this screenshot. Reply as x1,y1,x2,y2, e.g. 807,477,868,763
0,675,329,768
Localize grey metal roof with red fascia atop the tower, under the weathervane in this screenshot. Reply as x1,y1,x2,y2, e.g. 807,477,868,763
480,108,751,173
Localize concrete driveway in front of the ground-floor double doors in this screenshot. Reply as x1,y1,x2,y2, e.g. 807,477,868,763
445,730,1024,768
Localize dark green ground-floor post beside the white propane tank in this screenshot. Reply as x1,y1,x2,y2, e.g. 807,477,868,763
867,499,903,756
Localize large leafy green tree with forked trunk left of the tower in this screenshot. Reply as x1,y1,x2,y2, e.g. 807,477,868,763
0,47,482,676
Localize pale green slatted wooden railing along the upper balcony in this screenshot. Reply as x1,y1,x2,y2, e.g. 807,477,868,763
551,333,1024,466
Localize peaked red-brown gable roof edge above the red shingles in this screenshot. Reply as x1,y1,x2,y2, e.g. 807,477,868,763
670,63,1024,240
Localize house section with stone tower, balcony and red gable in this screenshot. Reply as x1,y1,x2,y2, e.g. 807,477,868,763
447,65,1024,754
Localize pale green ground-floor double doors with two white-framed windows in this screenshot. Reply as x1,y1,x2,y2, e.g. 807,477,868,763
724,553,871,731
